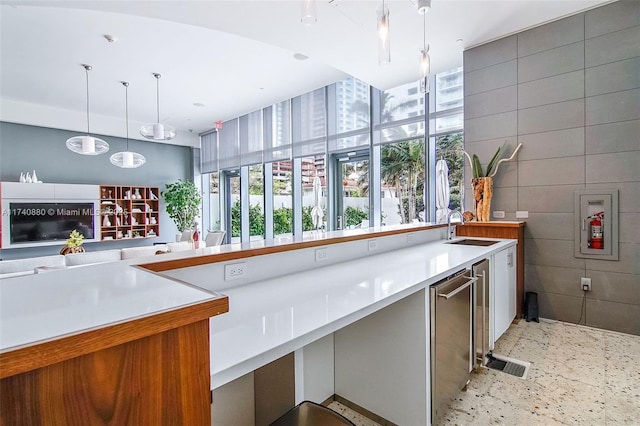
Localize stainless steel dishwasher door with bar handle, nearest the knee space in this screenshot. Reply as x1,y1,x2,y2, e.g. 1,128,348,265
429,269,477,424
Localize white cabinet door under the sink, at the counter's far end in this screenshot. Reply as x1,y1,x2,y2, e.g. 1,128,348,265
490,246,516,348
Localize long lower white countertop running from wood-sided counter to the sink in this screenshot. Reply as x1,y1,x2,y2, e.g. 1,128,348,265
210,237,516,389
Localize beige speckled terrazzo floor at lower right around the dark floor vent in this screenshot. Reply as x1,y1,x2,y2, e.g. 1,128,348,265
330,319,640,426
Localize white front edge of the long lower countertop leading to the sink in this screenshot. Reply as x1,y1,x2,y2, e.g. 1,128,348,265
210,237,517,390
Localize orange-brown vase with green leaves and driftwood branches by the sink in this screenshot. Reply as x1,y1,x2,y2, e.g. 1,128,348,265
464,144,522,222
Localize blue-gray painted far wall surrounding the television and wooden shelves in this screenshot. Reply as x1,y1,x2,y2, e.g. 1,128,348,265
0,122,194,259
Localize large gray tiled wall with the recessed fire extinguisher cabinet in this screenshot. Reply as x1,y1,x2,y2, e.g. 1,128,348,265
464,0,640,334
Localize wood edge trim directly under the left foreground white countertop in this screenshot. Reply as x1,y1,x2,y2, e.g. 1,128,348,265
0,296,229,379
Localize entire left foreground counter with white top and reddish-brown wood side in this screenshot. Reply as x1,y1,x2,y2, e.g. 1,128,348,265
0,262,228,426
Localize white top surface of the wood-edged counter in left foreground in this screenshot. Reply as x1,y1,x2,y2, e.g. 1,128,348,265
0,262,219,352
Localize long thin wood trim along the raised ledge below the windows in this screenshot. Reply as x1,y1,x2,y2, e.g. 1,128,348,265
138,225,447,272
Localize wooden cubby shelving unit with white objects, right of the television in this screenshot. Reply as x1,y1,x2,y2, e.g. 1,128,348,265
100,185,160,241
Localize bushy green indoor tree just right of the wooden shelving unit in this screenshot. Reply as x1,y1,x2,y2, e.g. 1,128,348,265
162,179,202,232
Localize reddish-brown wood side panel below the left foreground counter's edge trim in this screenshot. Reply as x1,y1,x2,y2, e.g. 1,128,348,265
0,319,211,426
